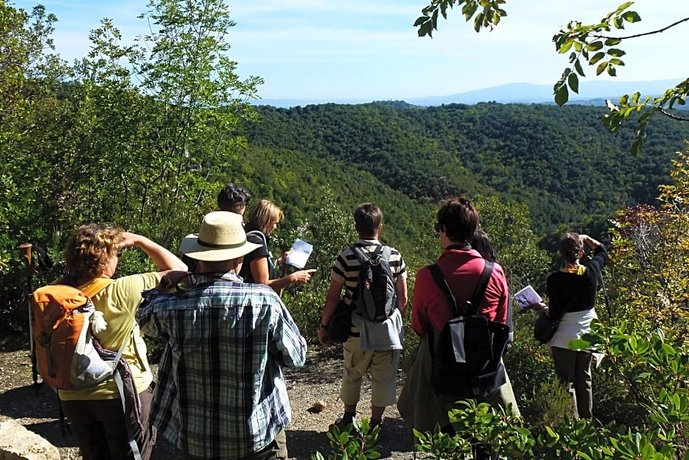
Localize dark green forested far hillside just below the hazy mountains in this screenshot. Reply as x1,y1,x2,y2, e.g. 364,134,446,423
249,103,689,234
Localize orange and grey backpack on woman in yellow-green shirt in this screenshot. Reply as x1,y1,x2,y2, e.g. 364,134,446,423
31,278,121,390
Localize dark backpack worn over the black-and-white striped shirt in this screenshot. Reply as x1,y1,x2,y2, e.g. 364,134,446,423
352,245,397,322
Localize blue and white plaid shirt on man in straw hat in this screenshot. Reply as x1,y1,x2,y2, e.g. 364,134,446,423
137,273,306,459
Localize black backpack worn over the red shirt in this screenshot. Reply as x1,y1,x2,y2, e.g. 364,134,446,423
428,261,510,402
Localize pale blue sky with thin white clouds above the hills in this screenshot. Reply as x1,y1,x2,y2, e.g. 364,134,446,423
8,0,689,102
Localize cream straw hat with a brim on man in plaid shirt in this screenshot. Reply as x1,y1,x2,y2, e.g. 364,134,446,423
179,211,260,262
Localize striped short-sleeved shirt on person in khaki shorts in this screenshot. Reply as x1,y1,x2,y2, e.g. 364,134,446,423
330,240,407,305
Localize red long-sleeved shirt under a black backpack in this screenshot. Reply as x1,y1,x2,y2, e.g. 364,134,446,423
412,249,509,336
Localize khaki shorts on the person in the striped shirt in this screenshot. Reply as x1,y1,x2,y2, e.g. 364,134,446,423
340,337,400,407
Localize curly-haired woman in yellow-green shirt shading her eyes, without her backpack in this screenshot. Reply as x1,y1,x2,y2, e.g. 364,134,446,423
59,224,187,460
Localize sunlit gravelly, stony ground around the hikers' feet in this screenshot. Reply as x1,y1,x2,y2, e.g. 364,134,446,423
0,340,414,460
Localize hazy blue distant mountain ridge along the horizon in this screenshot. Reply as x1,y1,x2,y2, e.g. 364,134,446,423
254,78,683,108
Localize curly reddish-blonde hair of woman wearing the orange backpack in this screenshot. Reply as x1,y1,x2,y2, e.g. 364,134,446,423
65,224,124,279
